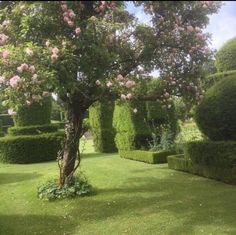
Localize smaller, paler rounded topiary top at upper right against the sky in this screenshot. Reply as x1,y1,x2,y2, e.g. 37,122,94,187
215,37,236,72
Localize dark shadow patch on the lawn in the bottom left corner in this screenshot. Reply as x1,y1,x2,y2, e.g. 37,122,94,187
0,215,74,235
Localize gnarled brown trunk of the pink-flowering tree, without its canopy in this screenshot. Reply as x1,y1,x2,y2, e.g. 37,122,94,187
59,107,84,187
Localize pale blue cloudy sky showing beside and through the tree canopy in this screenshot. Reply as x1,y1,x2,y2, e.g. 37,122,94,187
126,1,236,77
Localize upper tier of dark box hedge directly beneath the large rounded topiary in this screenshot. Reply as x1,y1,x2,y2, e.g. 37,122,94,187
184,141,236,168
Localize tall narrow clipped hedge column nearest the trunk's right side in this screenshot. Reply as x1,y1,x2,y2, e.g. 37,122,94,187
89,101,117,153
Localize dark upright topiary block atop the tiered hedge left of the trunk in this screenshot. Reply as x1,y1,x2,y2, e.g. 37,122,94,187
14,97,52,126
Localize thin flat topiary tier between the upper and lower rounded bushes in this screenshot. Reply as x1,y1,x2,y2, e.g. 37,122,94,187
202,70,236,90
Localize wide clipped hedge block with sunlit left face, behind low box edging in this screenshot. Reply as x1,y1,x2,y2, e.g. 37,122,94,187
113,101,151,150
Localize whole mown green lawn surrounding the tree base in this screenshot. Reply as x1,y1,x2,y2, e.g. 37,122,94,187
0,142,236,235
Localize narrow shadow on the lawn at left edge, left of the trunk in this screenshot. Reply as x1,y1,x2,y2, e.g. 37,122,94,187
0,173,41,185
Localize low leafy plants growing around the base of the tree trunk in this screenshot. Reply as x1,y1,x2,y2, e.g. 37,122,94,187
38,174,93,201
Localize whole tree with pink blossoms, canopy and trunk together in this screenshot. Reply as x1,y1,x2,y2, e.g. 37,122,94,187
0,1,220,186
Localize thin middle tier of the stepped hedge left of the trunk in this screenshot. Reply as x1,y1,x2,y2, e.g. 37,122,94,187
8,124,59,136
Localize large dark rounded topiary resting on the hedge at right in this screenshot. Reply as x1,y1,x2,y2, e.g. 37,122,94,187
195,75,236,140
